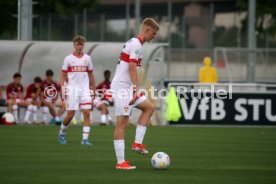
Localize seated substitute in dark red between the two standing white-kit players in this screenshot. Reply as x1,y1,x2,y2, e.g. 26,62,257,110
93,70,113,125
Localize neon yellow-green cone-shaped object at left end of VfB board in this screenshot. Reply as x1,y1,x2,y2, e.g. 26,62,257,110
166,87,181,122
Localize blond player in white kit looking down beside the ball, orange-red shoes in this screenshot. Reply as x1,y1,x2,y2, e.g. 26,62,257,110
111,18,159,169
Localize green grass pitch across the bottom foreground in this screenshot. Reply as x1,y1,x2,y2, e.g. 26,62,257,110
0,126,276,184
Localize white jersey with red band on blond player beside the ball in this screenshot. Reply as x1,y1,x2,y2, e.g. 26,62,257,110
112,37,143,85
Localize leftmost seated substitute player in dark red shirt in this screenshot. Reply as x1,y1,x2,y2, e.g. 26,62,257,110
6,73,29,123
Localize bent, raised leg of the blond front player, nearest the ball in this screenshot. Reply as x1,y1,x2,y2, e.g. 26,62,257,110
132,99,154,154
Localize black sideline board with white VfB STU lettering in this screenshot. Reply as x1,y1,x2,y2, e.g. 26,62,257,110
168,83,276,125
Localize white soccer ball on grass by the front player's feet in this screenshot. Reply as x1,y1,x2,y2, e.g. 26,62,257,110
151,152,170,169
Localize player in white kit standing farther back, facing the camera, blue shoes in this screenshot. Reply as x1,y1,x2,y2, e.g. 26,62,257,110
59,36,95,145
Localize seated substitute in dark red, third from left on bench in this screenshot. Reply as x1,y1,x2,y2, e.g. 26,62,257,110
41,69,66,124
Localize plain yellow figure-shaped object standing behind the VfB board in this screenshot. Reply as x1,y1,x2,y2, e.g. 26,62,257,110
199,57,218,83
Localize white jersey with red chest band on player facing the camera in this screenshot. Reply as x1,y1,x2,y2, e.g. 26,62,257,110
62,53,93,90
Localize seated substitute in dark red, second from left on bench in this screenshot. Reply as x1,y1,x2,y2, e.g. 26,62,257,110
24,77,43,124
